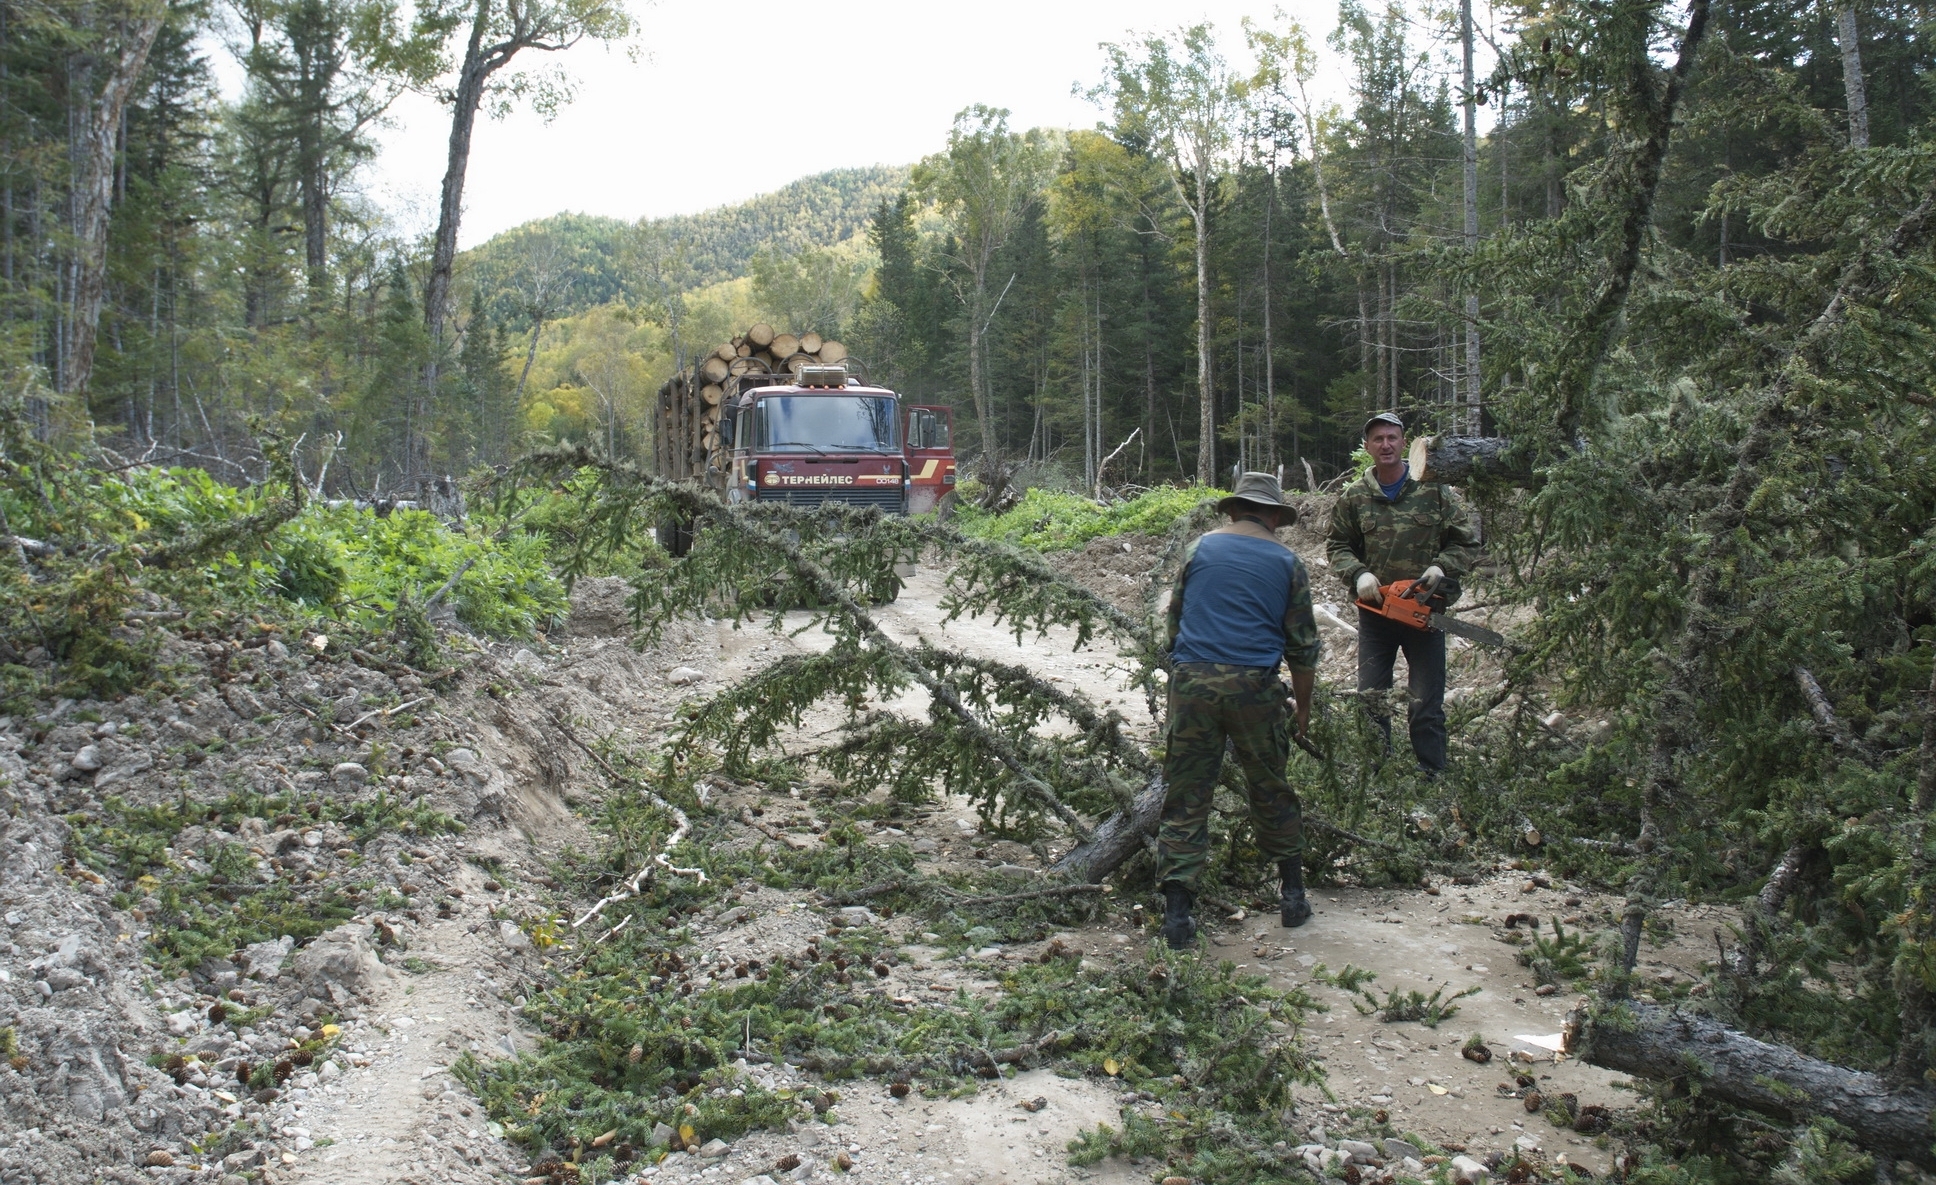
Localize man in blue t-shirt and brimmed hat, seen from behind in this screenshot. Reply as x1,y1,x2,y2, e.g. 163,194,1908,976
1156,472,1322,951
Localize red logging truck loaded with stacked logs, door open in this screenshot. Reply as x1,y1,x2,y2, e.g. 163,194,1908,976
654,325,954,556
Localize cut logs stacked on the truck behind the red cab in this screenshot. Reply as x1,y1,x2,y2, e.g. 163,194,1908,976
654,323,848,478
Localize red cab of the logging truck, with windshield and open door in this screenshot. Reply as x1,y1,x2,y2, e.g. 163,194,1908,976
720,366,954,515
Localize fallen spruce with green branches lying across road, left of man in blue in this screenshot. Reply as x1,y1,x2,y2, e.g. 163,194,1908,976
495,449,1417,898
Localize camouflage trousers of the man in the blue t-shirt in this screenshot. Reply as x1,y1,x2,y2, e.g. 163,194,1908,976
1156,662,1305,887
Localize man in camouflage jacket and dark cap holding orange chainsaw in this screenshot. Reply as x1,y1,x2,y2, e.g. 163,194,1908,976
1328,412,1479,776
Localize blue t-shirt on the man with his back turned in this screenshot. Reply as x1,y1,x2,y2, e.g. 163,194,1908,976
1169,534,1309,668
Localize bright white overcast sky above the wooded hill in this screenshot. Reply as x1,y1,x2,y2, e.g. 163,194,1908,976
364,0,1483,246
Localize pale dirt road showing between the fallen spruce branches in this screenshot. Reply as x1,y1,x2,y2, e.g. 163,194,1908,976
49,558,1706,1185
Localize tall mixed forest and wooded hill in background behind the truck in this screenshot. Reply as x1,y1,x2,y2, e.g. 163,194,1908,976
15,0,1924,490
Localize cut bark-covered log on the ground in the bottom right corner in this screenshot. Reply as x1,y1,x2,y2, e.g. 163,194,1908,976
1566,1001,1936,1168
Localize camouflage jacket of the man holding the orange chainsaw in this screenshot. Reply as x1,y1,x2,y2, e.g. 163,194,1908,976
1326,469,1479,596
